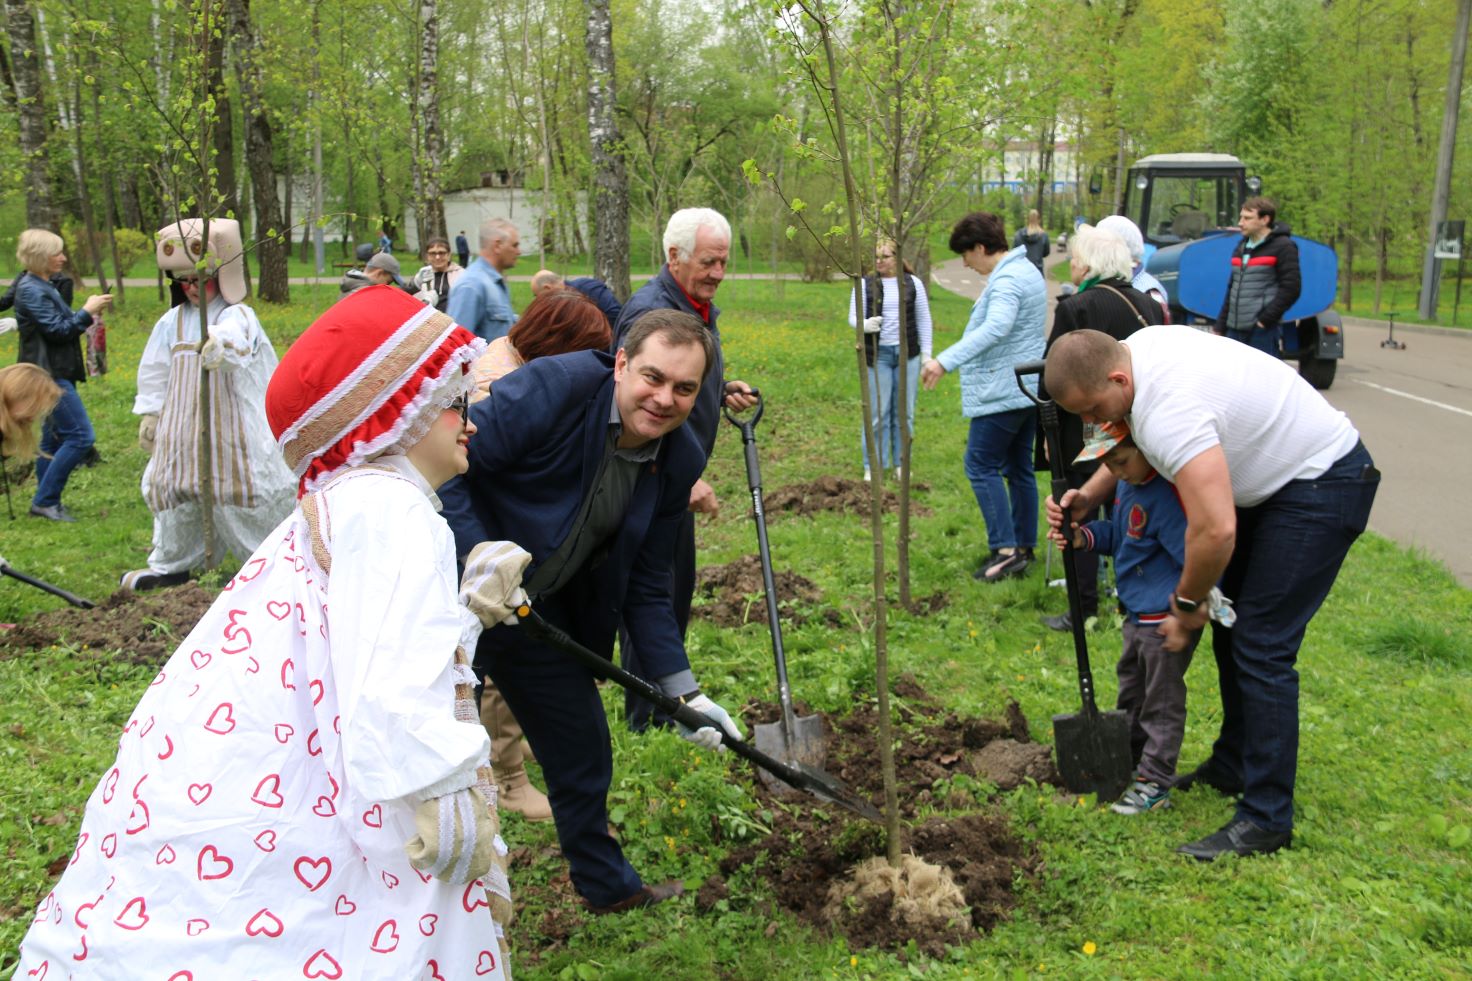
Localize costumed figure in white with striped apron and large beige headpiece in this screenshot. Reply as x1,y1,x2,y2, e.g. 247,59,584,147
122,218,296,589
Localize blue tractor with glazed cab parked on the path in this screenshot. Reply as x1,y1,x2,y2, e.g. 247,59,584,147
1125,153,1344,389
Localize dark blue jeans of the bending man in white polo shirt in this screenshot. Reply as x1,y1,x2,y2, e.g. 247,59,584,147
1209,443,1379,831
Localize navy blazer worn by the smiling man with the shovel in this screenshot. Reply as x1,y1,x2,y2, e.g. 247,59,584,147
439,351,705,679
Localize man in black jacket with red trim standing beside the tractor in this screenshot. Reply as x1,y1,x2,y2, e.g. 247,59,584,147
1216,197,1303,358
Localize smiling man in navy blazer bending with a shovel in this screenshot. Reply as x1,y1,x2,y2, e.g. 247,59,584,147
440,311,740,913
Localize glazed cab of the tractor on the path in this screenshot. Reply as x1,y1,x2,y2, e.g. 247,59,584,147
1125,153,1262,249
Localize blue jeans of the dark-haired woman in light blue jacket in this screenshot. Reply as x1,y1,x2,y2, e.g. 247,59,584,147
966,408,1038,551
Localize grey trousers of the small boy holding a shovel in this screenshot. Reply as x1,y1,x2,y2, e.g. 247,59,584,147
1116,619,1201,790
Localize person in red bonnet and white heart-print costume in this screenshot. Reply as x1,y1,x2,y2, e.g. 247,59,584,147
16,286,526,981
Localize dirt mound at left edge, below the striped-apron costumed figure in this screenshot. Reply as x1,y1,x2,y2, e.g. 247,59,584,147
0,582,215,664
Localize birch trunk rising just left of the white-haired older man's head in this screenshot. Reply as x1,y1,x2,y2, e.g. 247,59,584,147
586,0,630,300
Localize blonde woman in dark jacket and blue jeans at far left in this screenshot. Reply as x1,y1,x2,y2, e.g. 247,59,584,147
15,228,112,521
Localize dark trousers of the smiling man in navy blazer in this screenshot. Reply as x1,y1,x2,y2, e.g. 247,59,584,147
477,615,643,906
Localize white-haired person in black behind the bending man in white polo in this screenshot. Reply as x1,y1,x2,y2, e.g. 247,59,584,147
1035,225,1164,630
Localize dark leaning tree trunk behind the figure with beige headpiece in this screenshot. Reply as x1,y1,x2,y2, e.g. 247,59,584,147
225,0,291,303
